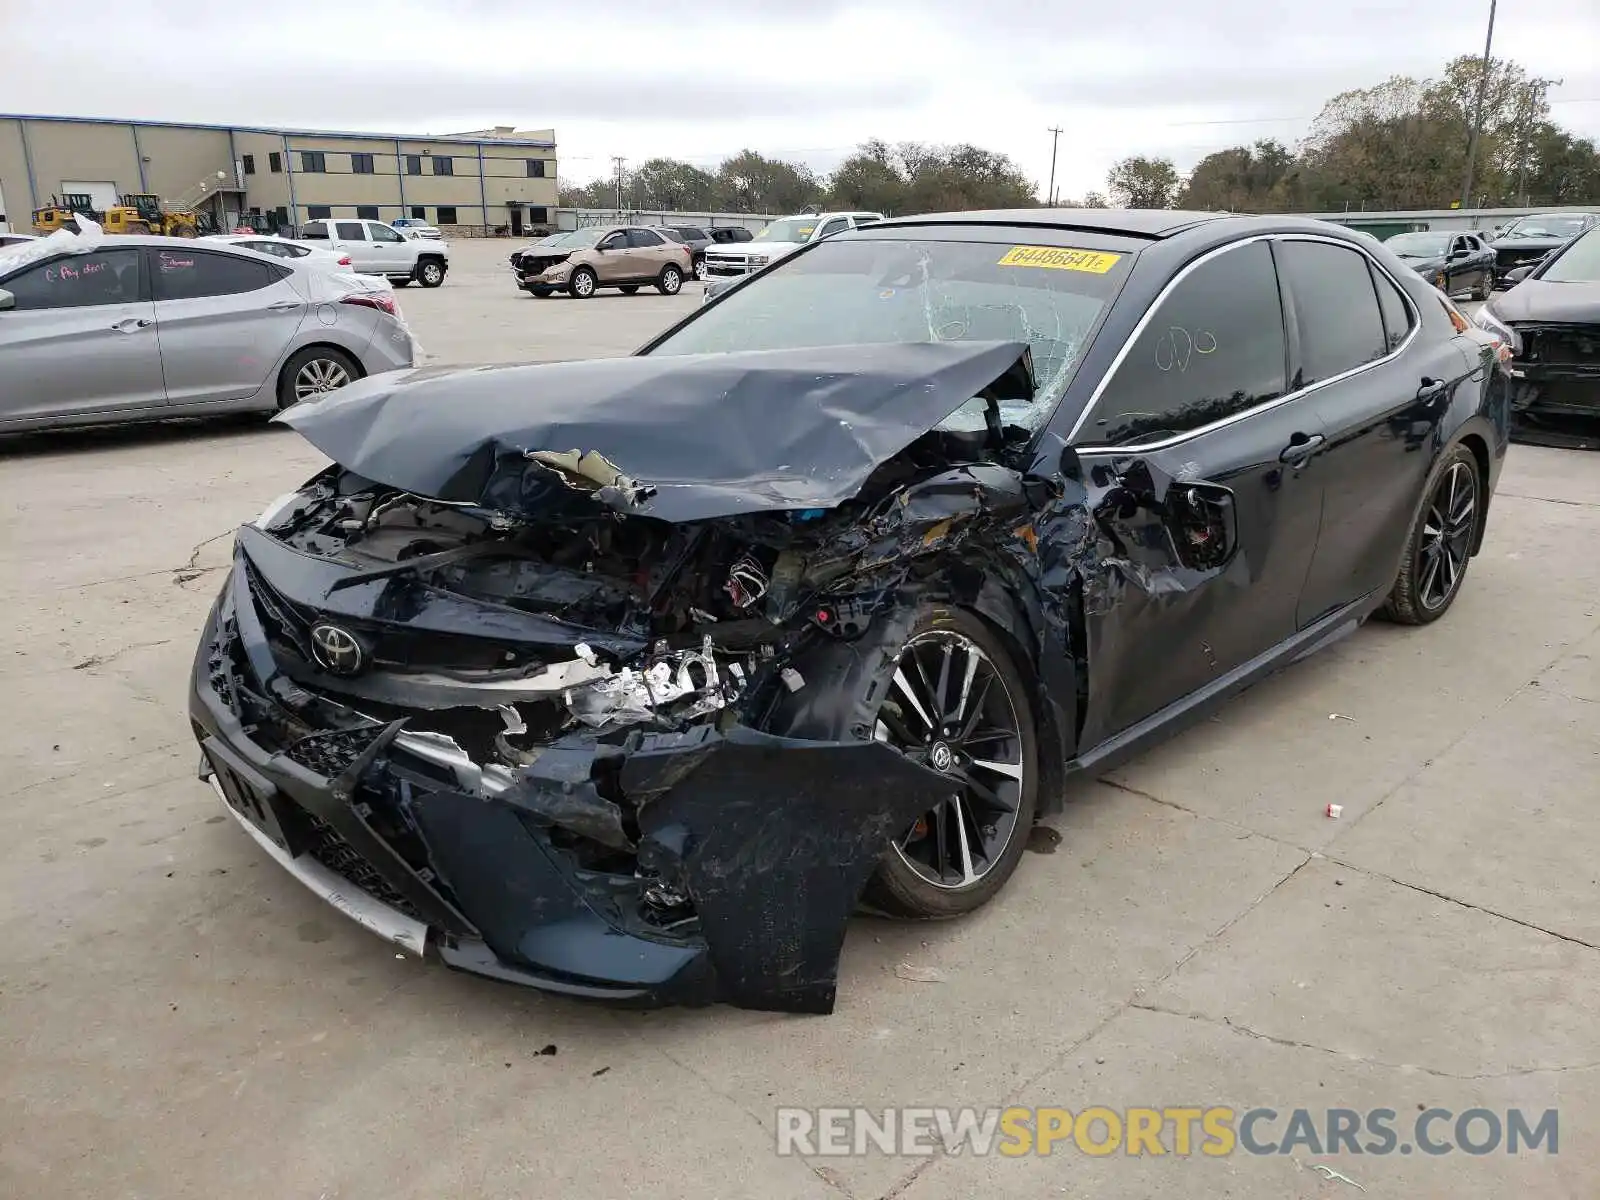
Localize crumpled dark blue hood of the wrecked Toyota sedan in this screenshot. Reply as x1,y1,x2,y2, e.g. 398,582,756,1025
277,342,1034,522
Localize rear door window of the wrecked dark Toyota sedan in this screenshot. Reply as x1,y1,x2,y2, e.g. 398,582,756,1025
1273,242,1389,387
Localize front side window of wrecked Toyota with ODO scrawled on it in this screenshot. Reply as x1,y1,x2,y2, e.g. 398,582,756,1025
1085,242,1286,445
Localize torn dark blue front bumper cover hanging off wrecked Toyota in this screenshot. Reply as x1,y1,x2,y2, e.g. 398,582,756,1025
190,563,947,1013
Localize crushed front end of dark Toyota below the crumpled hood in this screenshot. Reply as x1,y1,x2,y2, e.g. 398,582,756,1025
190,467,1024,1011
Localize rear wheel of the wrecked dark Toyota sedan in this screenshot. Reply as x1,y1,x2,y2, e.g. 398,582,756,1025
1379,446,1483,626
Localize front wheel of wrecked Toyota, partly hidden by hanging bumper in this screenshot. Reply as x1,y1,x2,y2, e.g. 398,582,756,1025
864,608,1038,920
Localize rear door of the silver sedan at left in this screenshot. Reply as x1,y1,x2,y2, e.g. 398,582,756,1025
149,250,307,405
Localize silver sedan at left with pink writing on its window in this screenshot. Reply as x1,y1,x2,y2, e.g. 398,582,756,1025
0,235,413,432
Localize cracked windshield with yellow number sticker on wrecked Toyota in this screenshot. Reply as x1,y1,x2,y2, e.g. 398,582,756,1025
650,238,1133,429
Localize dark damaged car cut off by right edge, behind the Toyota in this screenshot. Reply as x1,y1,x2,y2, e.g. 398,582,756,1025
1474,226,1600,422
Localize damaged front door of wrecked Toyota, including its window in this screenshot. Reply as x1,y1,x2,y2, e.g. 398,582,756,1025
1072,240,1323,749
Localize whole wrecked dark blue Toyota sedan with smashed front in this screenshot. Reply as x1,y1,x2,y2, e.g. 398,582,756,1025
190,210,1506,1011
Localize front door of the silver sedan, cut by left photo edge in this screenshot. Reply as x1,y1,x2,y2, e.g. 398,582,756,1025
0,250,166,424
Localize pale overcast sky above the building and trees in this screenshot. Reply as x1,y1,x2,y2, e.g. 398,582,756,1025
0,0,1600,195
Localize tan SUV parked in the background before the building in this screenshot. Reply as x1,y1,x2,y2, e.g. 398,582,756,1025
517,226,693,299
